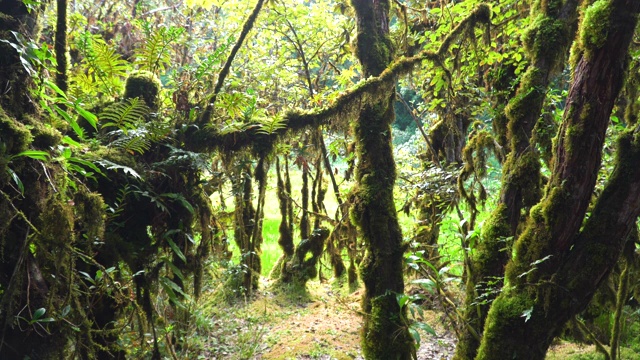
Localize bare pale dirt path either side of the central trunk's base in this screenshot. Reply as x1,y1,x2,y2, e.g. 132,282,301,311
238,282,455,360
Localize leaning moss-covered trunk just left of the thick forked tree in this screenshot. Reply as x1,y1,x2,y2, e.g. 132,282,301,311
454,0,578,360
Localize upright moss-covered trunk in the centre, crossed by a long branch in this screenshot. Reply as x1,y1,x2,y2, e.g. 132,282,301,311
351,0,413,359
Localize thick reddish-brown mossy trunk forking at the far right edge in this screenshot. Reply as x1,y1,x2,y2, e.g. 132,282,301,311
476,0,640,360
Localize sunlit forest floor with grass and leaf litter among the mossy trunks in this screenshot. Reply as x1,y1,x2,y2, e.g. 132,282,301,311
194,280,608,360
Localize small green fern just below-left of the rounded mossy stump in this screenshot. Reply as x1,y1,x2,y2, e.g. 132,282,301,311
99,98,151,135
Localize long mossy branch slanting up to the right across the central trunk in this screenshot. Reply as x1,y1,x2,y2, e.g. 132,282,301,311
185,4,491,152
